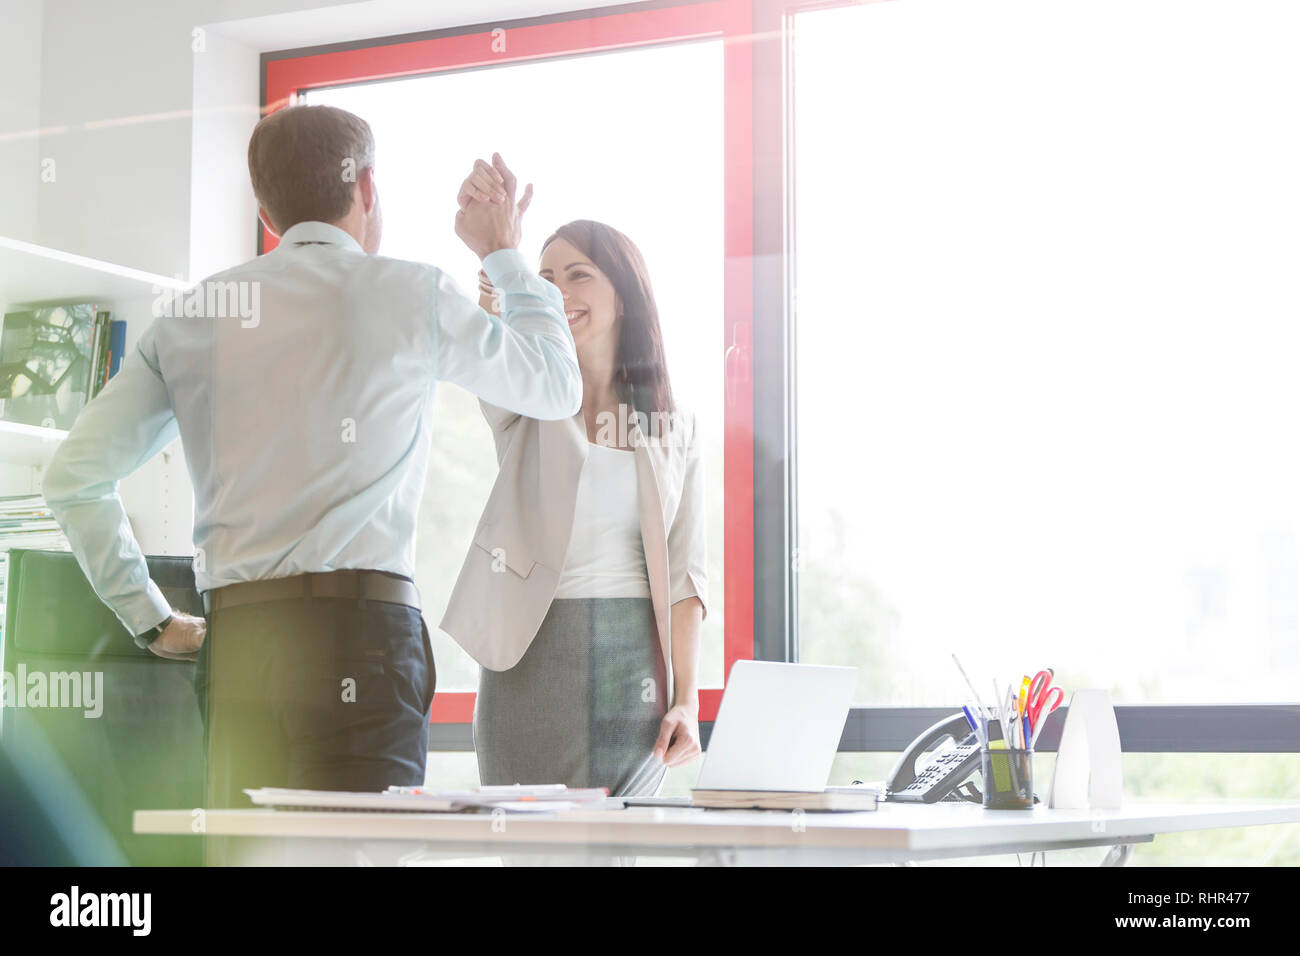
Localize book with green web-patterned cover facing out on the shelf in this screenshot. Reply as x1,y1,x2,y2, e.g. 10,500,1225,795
0,302,112,429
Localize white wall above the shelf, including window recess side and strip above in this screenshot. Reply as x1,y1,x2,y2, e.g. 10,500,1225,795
32,0,631,278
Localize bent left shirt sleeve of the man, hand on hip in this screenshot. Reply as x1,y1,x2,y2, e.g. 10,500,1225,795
43,319,178,635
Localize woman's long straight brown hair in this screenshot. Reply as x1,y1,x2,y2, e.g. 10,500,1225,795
542,219,675,415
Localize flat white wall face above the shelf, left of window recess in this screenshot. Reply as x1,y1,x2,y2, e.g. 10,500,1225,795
38,0,345,276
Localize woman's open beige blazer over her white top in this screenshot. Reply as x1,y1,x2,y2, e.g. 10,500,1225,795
441,402,709,701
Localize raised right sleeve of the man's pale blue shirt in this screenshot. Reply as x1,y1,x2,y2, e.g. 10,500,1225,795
433,248,582,420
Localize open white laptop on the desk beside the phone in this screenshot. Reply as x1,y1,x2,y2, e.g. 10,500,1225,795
624,661,858,806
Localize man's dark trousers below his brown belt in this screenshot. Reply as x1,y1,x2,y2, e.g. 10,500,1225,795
195,597,437,808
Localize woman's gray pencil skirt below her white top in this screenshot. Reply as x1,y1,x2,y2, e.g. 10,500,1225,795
475,597,667,796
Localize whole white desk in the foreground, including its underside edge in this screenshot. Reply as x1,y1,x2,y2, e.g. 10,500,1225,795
135,803,1300,866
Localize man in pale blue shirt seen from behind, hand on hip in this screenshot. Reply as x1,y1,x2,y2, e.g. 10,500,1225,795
44,107,582,806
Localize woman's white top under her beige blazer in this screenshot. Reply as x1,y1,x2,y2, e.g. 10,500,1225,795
555,444,650,598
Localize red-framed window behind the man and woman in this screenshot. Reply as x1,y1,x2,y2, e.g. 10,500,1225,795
263,0,753,723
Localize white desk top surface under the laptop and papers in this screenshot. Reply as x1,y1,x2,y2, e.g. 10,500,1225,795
135,801,1300,855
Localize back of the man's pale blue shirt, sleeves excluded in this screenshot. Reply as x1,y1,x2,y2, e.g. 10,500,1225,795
149,222,445,591
